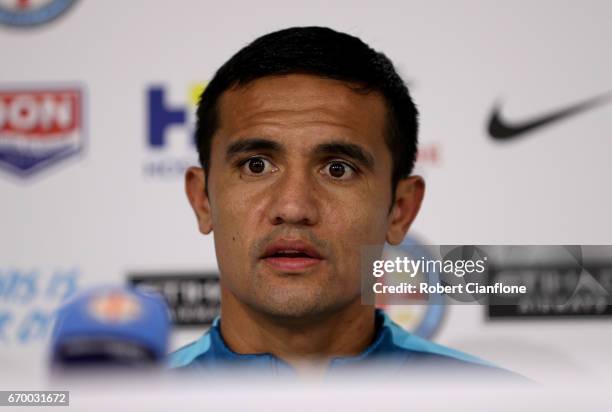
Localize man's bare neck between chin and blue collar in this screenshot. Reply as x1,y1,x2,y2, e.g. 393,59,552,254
221,290,375,371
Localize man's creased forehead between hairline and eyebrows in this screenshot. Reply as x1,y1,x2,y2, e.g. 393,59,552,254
218,74,387,143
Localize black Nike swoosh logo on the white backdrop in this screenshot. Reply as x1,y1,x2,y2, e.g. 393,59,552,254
489,93,612,141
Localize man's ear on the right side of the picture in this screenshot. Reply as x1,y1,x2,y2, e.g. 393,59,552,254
386,176,425,245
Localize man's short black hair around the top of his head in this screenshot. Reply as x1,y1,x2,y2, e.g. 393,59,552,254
195,27,418,198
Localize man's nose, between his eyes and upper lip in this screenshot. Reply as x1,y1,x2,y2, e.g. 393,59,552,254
268,166,320,226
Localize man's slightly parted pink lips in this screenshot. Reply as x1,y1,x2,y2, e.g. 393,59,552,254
261,239,323,272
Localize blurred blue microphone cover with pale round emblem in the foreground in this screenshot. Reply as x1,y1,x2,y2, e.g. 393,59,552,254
51,287,170,371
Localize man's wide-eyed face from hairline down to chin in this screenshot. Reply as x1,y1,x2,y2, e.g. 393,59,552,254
187,74,420,318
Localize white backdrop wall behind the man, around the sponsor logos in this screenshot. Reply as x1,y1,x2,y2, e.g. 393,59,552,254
0,0,612,379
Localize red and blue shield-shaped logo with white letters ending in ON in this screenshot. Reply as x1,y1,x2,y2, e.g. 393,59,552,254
0,87,85,177
